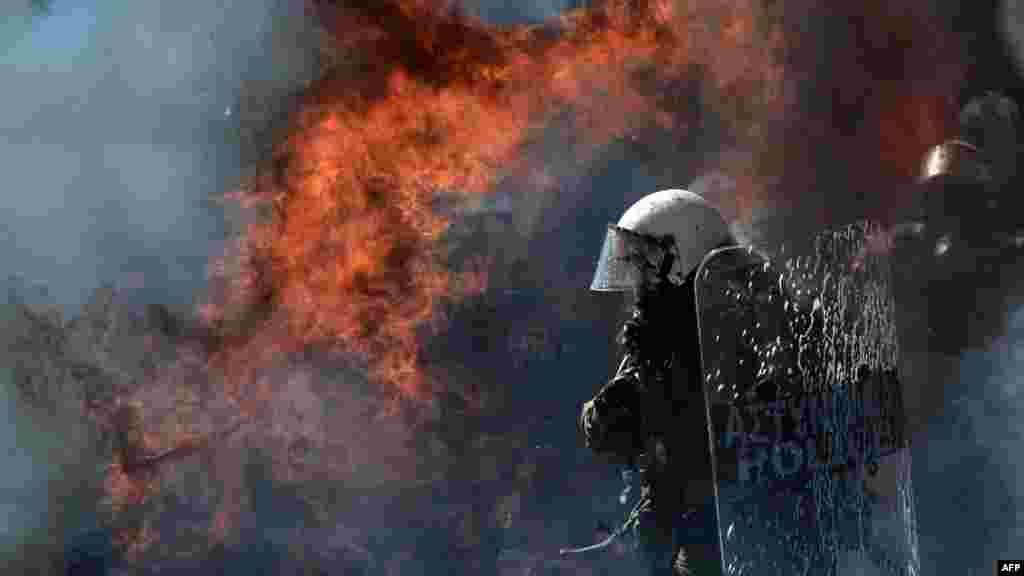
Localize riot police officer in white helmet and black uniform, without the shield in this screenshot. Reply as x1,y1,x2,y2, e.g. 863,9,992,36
580,190,735,576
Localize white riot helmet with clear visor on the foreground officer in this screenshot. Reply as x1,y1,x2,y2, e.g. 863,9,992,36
590,190,735,292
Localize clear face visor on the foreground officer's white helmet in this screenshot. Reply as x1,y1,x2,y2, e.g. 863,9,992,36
590,224,675,292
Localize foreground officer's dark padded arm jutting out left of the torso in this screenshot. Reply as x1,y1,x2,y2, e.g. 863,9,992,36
580,355,643,459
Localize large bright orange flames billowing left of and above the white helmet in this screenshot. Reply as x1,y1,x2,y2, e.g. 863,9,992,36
201,0,777,398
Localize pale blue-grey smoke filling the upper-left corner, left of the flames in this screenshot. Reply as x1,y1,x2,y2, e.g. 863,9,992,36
0,0,315,308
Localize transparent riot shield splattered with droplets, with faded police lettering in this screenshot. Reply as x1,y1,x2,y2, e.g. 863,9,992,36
696,224,920,576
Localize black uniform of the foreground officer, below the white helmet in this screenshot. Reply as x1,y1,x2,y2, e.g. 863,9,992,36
580,274,720,576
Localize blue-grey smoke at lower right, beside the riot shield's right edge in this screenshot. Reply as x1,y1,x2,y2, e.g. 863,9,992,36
914,308,1024,574
